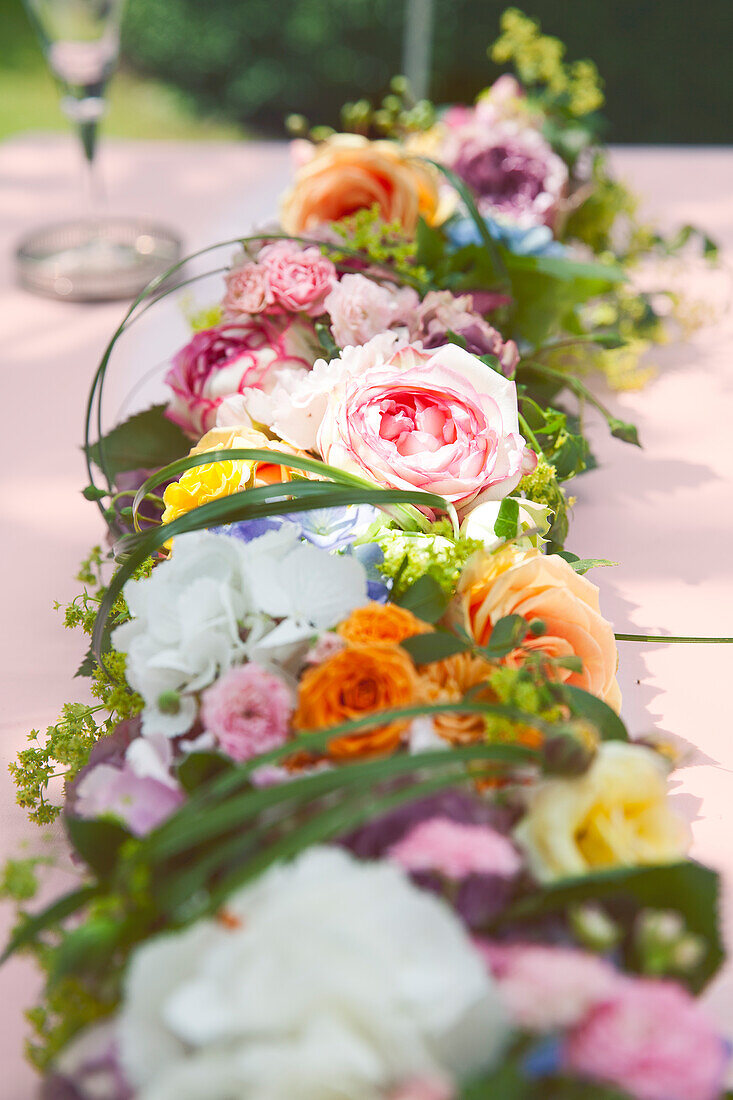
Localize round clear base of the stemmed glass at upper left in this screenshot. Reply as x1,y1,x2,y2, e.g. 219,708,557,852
15,218,180,301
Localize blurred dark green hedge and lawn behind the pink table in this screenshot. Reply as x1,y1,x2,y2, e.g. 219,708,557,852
0,0,733,144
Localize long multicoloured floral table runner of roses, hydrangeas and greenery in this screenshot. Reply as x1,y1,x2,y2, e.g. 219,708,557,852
3,13,727,1100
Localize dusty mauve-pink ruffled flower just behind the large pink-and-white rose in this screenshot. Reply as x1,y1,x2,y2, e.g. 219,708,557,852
409,290,519,377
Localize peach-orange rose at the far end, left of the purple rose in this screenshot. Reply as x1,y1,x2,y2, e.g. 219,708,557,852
281,134,445,234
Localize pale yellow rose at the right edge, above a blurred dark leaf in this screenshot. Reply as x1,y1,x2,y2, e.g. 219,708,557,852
514,741,690,882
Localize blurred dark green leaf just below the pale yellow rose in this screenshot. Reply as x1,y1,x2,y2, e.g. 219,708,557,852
496,860,724,992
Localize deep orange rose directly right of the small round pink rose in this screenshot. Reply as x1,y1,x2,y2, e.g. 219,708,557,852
293,646,417,760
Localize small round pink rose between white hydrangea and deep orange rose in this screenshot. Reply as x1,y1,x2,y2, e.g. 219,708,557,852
201,662,293,760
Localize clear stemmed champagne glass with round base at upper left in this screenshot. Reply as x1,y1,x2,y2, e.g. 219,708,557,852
17,0,180,301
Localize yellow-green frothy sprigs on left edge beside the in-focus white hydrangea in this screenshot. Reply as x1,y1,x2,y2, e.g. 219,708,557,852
9,547,147,825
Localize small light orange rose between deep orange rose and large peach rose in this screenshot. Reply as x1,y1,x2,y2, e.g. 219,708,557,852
419,653,494,745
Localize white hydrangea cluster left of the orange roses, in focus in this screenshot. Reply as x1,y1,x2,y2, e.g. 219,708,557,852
112,525,367,737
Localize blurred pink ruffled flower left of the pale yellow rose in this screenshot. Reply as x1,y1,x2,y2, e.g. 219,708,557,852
387,817,522,882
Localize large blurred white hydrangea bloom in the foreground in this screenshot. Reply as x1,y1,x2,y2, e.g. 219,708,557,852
119,848,508,1100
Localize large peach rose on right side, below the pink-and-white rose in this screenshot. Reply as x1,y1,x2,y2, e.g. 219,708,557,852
457,547,621,711
